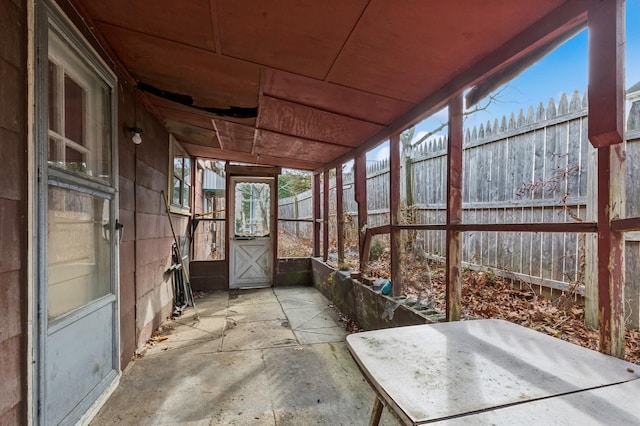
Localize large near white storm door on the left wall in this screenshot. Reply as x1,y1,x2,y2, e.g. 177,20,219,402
34,10,121,425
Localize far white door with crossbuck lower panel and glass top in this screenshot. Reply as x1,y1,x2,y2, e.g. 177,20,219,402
229,176,275,289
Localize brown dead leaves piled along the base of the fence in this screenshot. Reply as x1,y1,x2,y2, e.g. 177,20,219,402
370,251,640,364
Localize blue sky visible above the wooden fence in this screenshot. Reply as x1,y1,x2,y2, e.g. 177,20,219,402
367,0,640,162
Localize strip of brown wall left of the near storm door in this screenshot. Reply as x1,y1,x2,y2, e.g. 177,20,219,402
0,0,27,425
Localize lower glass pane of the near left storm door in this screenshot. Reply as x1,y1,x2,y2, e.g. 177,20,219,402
47,186,112,319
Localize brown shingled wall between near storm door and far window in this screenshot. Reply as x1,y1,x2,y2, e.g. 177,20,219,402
118,83,180,362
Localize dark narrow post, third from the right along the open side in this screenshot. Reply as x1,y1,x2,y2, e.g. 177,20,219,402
389,133,402,297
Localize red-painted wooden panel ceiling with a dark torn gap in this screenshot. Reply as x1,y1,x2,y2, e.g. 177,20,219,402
71,0,586,170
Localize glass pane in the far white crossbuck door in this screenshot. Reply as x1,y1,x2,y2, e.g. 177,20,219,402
235,182,271,237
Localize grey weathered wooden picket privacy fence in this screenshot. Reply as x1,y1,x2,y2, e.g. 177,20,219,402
279,91,640,327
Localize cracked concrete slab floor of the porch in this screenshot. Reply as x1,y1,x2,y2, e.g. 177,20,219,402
91,287,398,426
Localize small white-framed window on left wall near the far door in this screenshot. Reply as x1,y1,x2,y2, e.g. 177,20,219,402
167,134,193,215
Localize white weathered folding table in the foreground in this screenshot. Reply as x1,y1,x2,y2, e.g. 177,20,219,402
347,320,640,425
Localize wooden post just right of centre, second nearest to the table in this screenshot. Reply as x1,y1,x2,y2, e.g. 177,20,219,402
446,93,464,321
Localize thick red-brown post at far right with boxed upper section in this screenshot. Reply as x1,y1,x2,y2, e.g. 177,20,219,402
588,0,625,358
